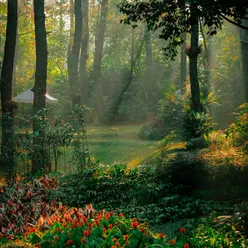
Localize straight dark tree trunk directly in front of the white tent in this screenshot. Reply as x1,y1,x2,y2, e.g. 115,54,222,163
33,0,47,173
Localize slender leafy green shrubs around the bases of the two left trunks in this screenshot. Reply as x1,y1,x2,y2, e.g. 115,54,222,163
7,106,91,176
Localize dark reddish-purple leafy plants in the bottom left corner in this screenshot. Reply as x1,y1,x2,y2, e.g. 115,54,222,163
0,177,58,238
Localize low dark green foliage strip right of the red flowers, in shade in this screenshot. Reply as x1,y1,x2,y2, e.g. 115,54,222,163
107,197,222,225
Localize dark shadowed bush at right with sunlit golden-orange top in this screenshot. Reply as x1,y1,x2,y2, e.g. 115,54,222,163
156,147,248,196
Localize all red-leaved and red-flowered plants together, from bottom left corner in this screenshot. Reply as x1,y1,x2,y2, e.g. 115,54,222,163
0,177,190,248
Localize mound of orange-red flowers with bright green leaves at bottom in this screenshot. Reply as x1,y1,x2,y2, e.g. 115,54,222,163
22,205,170,248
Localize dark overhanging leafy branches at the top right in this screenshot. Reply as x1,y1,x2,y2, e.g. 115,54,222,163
118,0,248,57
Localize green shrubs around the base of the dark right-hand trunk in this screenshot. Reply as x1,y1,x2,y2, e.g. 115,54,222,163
139,88,216,146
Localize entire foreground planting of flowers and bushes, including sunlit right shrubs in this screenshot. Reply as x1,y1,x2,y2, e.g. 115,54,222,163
0,106,248,248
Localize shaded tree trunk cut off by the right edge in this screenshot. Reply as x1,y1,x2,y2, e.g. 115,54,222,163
240,16,248,102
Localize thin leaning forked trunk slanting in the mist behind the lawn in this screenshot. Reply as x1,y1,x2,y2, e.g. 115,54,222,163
105,30,144,124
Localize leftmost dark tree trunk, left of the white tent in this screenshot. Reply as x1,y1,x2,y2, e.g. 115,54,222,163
1,0,18,176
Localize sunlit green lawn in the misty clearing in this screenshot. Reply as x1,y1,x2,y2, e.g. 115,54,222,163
86,126,157,167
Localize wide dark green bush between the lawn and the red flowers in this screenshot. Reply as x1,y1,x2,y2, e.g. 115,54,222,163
49,164,175,208
